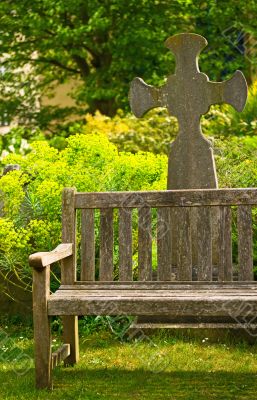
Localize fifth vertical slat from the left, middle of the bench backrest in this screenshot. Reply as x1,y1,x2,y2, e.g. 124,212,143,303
157,207,172,281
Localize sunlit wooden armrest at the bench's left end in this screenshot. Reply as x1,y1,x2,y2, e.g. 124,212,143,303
29,243,72,270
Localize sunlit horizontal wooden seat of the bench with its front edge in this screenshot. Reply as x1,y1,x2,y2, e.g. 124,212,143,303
48,282,257,318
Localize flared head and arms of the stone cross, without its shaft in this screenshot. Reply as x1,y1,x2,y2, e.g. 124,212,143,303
129,34,247,123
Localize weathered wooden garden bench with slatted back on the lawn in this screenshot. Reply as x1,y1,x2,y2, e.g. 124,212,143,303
29,189,257,388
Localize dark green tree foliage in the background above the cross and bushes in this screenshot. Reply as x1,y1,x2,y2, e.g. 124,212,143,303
0,0,257,130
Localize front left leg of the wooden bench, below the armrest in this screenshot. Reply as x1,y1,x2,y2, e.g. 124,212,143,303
33,267,52,389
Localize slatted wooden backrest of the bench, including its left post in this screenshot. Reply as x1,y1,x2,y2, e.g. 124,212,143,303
62,189,257,284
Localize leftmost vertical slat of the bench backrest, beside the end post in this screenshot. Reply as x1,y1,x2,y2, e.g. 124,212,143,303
80,209,95,281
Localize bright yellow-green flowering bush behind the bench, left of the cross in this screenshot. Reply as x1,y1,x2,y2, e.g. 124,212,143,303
0,133,167,294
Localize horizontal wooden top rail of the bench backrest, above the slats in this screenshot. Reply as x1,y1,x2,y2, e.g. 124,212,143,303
75,188,257,208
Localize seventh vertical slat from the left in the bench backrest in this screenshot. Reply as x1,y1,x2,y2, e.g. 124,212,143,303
197,207,212,281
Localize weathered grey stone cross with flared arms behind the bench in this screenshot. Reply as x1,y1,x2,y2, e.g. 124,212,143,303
129,33,247,189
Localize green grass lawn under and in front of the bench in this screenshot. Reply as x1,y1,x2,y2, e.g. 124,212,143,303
0,326,257,400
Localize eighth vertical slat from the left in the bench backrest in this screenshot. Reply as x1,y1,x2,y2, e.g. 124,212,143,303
218,206,233,281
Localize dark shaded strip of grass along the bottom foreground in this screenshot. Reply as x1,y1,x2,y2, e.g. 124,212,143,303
0,366,257,400
